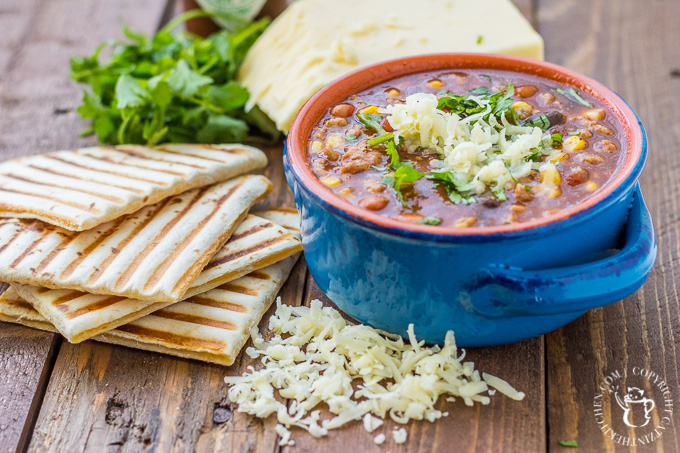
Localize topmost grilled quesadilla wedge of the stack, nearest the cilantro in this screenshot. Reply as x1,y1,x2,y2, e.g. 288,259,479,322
0,144,267,231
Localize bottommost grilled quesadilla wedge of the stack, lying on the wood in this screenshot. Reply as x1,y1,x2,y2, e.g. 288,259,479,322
0,211,299,365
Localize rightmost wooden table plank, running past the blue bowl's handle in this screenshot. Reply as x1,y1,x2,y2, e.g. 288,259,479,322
538,0,680,452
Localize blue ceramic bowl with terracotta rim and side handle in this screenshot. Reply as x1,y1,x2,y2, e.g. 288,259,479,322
284,54,656,346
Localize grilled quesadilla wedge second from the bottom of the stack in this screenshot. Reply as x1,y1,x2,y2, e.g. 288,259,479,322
9,210,302,343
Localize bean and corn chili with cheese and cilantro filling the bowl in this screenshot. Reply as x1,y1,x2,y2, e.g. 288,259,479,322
308,71,625,227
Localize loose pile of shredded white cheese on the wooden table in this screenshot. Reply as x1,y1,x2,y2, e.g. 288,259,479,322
225,298,524,445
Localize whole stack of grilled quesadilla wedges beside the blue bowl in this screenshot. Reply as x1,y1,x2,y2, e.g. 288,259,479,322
0,145,302,365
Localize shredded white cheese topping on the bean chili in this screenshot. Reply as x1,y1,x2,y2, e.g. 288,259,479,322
378,93,556,194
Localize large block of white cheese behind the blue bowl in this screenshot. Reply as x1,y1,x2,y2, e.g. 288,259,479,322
238,0,543,132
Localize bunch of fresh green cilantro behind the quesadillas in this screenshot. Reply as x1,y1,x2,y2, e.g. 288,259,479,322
71,11,279,145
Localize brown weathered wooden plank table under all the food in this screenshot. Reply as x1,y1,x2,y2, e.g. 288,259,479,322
0,0,680,453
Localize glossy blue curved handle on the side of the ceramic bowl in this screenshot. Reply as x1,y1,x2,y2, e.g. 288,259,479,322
460,186,656,317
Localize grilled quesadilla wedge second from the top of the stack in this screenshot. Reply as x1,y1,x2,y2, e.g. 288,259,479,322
0,175,272,303
